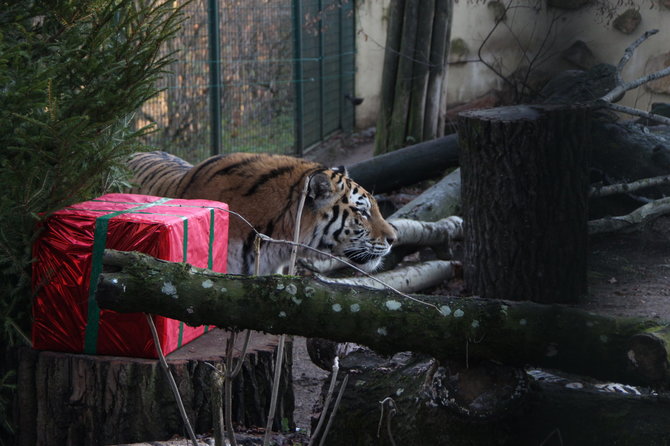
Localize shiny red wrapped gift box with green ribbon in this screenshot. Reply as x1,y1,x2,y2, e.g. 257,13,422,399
32,194,228,358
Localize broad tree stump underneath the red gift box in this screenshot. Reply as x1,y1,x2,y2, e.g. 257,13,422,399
16,330,293,446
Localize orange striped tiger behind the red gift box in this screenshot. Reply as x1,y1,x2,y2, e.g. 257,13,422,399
128,151,397,275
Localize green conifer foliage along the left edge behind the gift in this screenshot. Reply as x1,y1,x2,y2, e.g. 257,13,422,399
0,0,183,443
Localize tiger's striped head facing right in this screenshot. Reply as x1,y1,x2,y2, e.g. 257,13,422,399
306,167,397,272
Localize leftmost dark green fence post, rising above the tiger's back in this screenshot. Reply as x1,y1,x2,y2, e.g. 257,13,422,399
207,0,222,155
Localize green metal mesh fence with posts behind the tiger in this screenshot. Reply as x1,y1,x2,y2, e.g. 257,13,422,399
137,0,355,162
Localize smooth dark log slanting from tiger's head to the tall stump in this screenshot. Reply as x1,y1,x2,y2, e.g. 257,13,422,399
347,135,459,194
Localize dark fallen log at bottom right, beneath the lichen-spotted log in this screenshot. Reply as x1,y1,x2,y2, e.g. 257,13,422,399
318,352,670,446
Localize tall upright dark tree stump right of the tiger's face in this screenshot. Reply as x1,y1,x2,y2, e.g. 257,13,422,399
459,105,590,303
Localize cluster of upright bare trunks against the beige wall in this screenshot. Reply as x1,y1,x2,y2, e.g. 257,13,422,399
375,0,450,155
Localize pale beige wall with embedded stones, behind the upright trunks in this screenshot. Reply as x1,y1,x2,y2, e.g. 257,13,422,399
356,0,670,128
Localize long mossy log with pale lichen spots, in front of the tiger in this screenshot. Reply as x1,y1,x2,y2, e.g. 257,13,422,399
97,251,669,386
